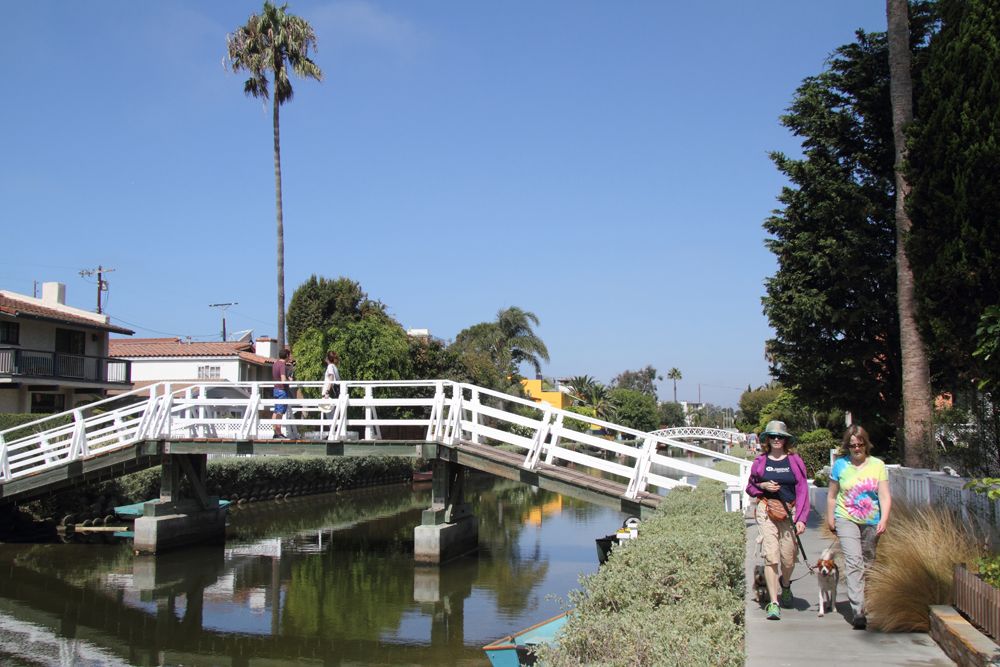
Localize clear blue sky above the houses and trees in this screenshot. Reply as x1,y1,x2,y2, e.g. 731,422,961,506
0,0,885,405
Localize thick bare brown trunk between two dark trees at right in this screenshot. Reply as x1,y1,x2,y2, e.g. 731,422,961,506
886,0,935,468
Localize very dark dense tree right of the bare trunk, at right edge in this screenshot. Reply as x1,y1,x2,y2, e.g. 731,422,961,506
906,0,1000,389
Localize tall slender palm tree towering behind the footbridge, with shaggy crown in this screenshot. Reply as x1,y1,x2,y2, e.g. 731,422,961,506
226,1,323,350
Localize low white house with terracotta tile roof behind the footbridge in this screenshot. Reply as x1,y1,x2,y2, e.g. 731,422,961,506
110,336,278,396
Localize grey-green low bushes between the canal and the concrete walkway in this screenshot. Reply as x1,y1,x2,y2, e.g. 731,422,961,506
540,480,745,667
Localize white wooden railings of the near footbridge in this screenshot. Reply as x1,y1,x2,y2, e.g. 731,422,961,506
0,380,750,510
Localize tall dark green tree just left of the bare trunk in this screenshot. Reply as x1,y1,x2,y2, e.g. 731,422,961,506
762,4,933,446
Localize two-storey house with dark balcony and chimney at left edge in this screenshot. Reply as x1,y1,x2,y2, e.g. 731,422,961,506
0,282,132,413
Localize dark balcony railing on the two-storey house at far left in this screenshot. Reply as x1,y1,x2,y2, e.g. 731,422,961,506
0,347,132,384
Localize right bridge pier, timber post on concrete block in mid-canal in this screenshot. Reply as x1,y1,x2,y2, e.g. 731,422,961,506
413,461,479,563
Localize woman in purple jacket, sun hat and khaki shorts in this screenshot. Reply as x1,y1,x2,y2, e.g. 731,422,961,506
747,421,809,621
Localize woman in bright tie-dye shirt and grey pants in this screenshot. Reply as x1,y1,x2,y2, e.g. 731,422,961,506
826,424,892,628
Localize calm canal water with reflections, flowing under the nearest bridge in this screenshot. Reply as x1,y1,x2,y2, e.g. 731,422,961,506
0,475,626,667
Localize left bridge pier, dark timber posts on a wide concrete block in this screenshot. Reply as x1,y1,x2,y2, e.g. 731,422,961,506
133,454,226,553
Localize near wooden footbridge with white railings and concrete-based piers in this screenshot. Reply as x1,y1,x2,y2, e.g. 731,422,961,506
0,380,750,561
